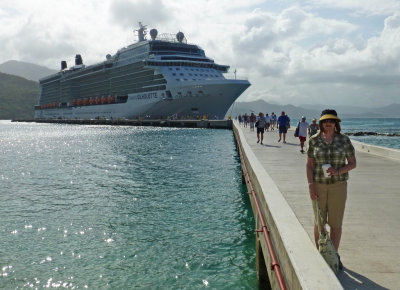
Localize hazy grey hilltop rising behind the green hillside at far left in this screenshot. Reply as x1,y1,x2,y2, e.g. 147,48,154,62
0,60,57,81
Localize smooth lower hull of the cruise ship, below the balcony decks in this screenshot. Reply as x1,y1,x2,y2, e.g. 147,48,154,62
35,79,250,119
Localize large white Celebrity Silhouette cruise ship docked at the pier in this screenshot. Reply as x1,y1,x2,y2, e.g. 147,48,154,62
35,23,250,119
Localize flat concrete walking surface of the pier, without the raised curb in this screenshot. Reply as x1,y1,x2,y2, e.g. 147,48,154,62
236,123,400,289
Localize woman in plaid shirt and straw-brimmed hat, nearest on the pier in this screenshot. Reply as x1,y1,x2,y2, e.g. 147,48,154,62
306,109,356,269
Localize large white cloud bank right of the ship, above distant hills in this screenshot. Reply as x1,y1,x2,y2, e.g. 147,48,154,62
230,7,400,105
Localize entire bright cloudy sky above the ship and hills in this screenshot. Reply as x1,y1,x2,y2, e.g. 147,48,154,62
0,0,400,107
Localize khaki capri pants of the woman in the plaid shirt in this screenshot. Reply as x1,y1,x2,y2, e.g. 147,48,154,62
313,181,347,228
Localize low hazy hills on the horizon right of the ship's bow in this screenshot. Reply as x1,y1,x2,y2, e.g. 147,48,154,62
228,100,400,120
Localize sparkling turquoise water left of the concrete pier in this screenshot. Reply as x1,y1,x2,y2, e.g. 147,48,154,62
0,121,258,289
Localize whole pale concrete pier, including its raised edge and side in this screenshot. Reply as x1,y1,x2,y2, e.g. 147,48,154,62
233,122,400,289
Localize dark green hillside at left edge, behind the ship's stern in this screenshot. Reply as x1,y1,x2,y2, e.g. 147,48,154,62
0,73,39,120
